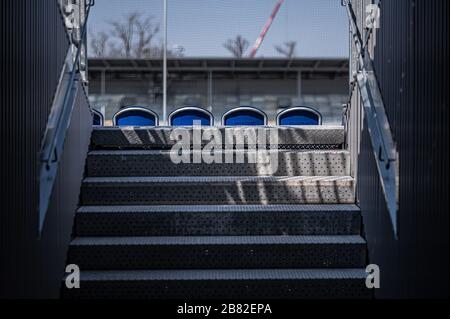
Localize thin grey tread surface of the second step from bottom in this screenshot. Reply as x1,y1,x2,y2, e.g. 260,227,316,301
71,235,366,246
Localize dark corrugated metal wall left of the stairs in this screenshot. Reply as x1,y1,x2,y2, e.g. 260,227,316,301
0,0,91,298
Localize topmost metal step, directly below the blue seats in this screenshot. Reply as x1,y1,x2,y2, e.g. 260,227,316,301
91,126,345,149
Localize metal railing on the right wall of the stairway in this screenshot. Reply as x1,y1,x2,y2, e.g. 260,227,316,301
342,0,399,237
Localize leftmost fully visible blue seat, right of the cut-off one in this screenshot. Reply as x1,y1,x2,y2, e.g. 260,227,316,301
113,106,159,127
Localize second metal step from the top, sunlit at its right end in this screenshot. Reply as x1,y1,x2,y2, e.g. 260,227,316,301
86,150,350,177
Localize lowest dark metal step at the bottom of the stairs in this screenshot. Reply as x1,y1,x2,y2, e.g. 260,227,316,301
62,269,372,300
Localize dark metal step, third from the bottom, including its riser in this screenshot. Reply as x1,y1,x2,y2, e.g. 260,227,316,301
75,205,361,236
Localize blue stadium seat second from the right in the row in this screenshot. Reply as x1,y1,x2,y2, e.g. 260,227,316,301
222,106,267,126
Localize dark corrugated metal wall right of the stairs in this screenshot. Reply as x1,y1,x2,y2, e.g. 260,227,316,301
358,0,449,298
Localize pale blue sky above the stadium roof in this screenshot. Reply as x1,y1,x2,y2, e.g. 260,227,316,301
89,0,349,58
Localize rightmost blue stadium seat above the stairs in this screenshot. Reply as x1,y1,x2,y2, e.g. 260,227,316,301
277,106,322,126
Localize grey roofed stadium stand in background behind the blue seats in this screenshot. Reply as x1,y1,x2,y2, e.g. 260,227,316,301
89,58,349,125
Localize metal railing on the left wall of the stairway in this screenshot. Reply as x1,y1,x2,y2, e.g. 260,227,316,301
39,0,95,235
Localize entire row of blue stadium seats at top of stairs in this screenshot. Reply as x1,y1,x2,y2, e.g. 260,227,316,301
93,106,322,127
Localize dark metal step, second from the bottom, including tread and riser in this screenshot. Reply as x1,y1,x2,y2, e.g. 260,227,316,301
69,236,365,270
